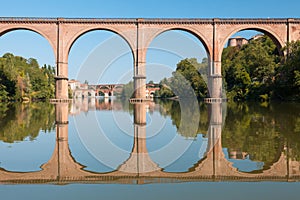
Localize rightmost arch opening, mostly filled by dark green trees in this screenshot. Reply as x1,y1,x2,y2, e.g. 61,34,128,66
221,28,283,101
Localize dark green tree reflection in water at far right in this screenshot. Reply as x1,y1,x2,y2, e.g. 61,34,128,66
222,103,300,169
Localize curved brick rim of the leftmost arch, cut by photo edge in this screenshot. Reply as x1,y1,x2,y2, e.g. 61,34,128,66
0,25,57,61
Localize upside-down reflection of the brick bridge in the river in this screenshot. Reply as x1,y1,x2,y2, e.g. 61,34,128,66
0,103,300,184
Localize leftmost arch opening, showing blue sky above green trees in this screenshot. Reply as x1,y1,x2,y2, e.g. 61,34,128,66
0,28,56,101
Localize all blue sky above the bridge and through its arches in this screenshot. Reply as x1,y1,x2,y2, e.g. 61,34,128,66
0,0,300,83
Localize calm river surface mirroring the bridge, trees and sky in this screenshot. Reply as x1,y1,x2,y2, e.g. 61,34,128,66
0,99,300,199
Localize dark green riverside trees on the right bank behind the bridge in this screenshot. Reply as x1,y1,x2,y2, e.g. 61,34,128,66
123,36,300,101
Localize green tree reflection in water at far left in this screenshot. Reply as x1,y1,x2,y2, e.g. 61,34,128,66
0,102,55,143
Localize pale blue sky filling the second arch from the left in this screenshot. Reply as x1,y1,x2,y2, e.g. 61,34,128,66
68,28,134,87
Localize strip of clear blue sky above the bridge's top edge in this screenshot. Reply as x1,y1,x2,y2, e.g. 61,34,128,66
1,0,300,18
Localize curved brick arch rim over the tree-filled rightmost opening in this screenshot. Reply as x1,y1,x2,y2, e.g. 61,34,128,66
217,25,285,60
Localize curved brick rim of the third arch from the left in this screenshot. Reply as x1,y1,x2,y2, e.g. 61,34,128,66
144,26,213,60
